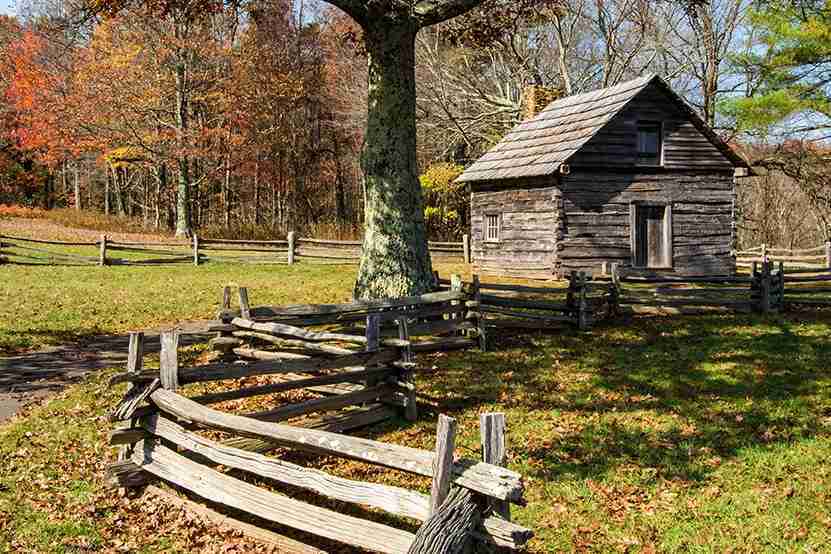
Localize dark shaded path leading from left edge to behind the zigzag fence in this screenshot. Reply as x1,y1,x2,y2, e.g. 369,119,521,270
0,321,209,422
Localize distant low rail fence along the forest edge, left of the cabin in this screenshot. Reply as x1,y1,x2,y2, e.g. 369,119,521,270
0,232,470,266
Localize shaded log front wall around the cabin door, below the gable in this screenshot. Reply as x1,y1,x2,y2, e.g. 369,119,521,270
554,168,736,275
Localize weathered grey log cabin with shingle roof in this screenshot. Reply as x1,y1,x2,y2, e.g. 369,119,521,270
458,75,750,278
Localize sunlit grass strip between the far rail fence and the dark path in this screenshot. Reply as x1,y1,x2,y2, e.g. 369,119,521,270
0,264,355,354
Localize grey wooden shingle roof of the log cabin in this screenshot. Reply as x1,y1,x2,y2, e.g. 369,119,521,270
457,75,747,182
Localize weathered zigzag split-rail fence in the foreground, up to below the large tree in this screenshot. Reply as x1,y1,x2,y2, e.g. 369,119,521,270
110,289,532,553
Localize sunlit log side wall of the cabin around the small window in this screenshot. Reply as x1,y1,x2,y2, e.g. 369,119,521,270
471,179,561,278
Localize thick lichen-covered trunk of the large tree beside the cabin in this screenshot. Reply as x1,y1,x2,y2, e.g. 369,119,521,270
354,22,435,299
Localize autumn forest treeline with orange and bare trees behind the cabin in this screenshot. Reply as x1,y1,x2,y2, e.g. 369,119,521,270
0,0,831,246
